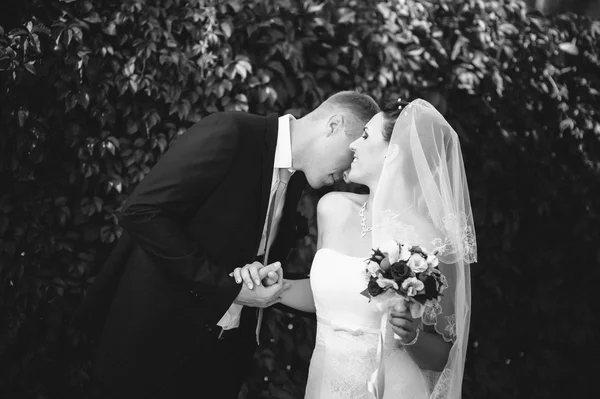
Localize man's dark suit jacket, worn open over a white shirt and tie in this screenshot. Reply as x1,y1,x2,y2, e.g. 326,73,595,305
78,112,306,398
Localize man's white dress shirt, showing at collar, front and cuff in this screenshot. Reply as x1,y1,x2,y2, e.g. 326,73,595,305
217,114,294,330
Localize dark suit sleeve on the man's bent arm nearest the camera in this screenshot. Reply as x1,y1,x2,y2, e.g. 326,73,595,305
120,114,240,302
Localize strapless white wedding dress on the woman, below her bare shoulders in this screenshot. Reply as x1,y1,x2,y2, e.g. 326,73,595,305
305,248,429,399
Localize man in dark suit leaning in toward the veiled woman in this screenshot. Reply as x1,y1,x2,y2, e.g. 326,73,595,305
80,91,379,399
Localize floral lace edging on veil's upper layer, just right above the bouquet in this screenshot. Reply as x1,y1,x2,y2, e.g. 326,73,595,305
432,213,477,263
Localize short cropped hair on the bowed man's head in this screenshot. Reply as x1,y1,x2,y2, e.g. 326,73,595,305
321,90,380,138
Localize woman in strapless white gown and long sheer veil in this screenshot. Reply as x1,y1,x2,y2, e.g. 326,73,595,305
234,100,476,399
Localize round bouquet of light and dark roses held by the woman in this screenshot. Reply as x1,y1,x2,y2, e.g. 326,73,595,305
361,241,448,338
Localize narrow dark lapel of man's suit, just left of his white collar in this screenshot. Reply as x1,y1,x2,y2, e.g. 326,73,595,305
256,114,279,245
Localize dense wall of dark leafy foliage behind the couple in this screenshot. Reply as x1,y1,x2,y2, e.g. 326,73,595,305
0,0,600,399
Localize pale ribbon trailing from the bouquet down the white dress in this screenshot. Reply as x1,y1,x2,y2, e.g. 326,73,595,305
367,294,425,399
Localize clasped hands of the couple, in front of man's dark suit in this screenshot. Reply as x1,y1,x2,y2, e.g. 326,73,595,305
230,262,290,308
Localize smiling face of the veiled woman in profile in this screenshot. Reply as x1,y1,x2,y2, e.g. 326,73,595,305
348,112,389,188
